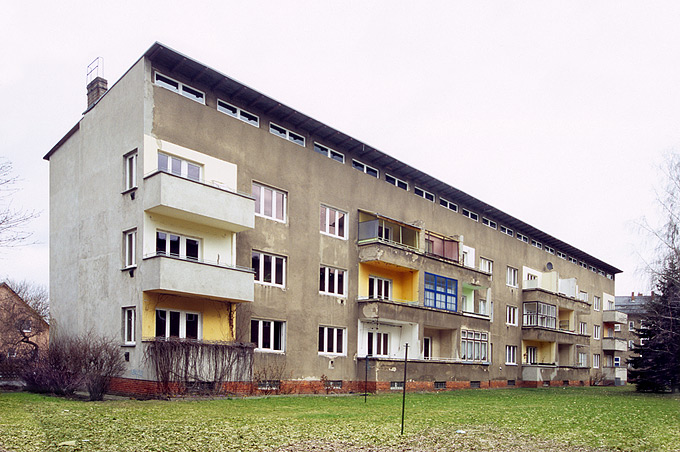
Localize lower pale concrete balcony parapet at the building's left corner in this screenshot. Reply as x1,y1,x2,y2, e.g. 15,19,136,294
139,255,254,302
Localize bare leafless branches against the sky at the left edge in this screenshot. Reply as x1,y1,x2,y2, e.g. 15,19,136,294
0,157,38,249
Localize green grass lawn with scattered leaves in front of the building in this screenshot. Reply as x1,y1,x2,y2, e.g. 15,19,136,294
0,387,680,451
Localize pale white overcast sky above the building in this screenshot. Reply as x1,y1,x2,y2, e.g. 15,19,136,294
0,0,680,295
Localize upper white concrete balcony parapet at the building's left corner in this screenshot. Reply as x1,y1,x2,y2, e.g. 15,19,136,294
143,172,255,232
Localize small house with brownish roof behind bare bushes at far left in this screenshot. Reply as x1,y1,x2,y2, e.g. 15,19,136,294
0,282,49,380
